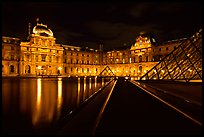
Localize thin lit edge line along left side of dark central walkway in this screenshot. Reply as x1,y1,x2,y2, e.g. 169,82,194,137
92,80,117,135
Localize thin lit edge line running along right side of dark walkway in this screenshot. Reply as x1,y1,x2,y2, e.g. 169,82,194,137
130,81,202,126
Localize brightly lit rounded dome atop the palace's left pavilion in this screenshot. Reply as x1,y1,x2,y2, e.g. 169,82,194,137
33,23,53,37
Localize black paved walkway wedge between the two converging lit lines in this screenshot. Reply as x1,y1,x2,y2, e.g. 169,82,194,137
95,80,202,135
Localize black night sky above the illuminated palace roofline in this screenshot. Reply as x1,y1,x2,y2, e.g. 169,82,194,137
2,2,202,49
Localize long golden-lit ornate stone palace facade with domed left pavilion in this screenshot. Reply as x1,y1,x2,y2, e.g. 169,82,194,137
2,19,185,79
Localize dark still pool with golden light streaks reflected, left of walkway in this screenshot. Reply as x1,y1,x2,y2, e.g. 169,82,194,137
2,77,110,133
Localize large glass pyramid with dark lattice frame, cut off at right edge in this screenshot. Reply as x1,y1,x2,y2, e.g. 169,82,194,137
140,29,202,82
